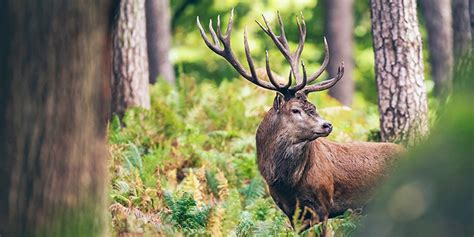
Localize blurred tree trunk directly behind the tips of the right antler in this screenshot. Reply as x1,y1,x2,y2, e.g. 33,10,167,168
325,0,354,106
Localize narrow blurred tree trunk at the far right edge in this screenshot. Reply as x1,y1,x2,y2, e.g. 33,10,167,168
452,0,472,59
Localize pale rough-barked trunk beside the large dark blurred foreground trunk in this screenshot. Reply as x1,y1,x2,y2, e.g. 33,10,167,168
112,0,150,116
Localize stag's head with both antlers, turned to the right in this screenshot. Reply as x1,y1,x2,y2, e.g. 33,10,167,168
197,9,344,143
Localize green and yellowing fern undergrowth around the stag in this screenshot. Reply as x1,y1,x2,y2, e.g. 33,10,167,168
108,75,378,236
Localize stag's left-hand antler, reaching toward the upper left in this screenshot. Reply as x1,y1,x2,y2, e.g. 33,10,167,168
196,11,278,90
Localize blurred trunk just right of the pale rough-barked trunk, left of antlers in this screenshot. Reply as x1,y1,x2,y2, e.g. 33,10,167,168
146,0,175,85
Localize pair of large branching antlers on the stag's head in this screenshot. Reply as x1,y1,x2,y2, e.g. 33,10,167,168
197,9,344,98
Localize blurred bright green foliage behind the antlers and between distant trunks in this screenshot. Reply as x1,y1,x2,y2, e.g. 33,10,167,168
170,0,432,104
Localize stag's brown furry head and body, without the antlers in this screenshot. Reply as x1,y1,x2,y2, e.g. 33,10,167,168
256,95,403,230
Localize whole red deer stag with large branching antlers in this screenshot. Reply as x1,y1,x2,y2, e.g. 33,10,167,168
197,10,403,231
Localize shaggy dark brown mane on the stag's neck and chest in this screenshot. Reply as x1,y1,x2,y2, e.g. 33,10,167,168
257,112,310,187
